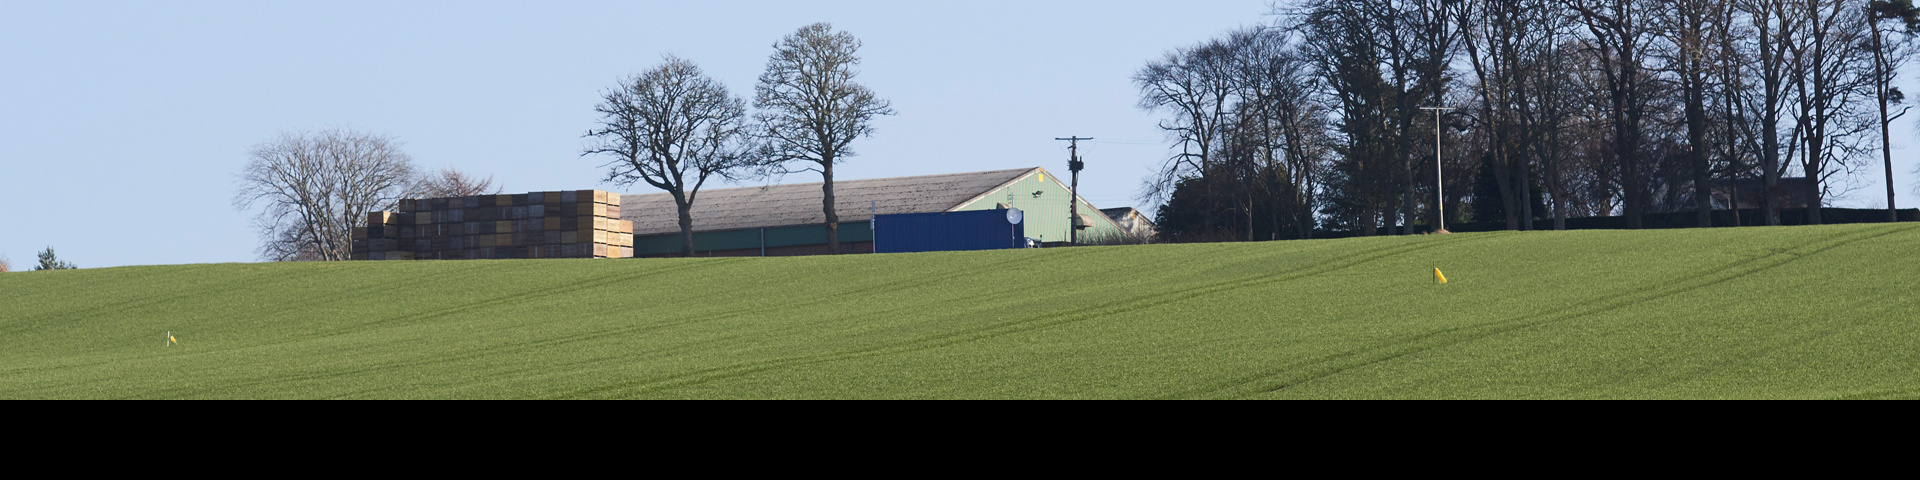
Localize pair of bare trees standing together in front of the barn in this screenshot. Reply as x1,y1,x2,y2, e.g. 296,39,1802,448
586,23,893,257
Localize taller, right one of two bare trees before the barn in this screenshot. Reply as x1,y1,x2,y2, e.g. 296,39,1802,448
753,23,893,253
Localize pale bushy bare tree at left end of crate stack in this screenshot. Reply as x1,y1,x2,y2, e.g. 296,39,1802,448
234,129,415,261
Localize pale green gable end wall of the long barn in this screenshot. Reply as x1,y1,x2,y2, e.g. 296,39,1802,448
958,171,1125,244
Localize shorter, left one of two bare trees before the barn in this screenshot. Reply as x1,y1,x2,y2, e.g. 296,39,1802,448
586,56,753,257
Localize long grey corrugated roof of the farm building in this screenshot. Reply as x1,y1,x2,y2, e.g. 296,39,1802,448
620,167,1039,236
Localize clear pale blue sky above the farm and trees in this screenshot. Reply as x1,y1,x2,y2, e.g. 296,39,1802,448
0,0,1920,267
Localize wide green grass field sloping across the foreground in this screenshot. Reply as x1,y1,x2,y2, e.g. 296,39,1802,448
0,223,1920,399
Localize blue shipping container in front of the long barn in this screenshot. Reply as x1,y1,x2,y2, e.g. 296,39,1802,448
874,209,1027,253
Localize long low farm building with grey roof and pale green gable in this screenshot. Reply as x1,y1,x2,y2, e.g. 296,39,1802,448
620,167,1125,257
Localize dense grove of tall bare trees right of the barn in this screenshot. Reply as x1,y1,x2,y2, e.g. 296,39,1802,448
1133,0,1920,240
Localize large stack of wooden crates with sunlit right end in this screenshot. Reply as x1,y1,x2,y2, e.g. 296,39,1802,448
353,190,634,259
